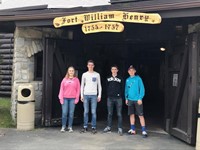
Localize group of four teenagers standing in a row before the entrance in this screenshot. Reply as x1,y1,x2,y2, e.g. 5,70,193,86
58,60,147,137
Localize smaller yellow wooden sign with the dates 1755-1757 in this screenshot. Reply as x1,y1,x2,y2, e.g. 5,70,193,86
82,22,124,34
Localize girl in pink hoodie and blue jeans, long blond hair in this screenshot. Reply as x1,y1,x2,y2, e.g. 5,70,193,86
58,66,80,132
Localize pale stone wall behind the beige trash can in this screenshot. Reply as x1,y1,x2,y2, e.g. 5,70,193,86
11,27,63,125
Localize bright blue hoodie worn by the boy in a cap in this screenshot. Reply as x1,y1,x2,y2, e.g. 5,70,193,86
125,75,145,101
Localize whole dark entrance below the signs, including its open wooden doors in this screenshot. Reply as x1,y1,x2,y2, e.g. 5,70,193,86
43,17,198,144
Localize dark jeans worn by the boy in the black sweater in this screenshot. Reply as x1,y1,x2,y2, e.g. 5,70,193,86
107,97,122,128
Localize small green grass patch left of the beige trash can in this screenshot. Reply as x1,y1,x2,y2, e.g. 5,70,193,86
0,97,15,128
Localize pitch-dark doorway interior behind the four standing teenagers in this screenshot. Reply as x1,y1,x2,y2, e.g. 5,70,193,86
43,39,165,130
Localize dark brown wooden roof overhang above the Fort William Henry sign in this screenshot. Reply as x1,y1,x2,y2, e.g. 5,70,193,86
0,0,200,26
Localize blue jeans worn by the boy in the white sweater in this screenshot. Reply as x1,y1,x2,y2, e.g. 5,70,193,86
83,95,97,128
